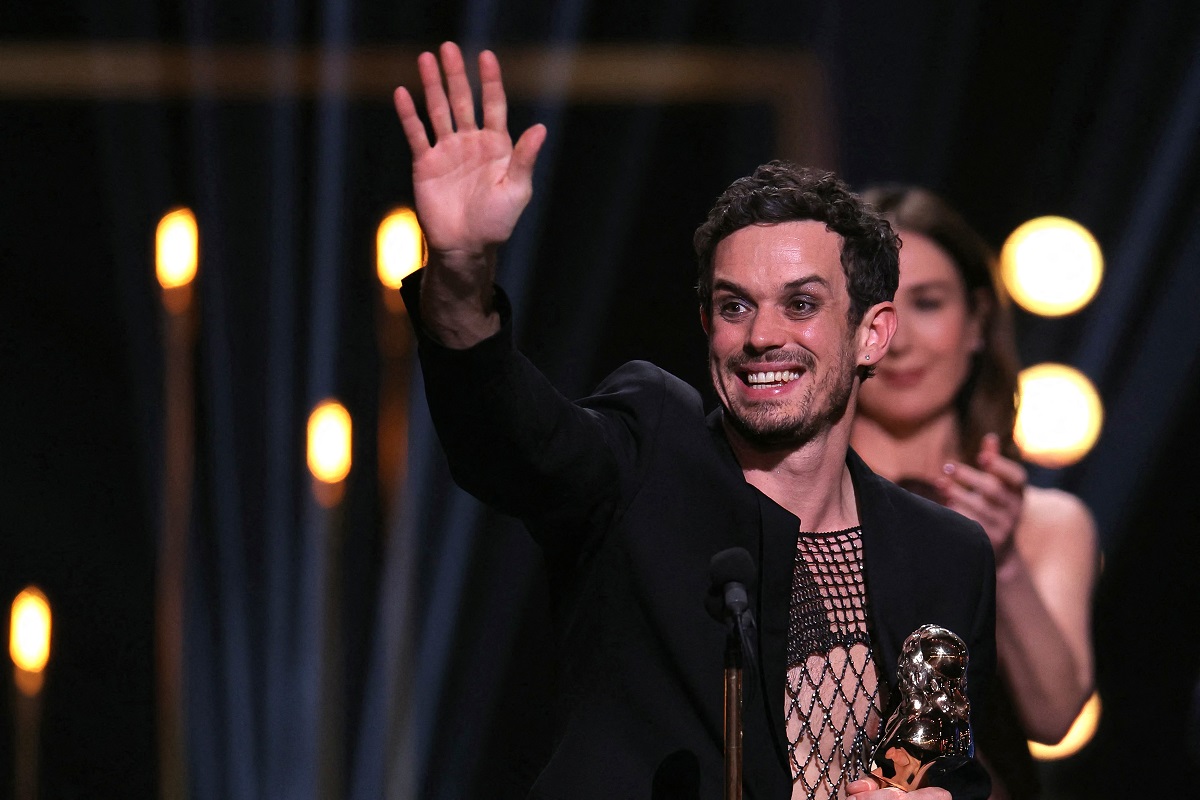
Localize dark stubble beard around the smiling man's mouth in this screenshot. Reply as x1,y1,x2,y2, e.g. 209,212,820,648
710,345,857,450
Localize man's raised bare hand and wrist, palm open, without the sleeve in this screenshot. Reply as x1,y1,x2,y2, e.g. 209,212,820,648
395,42,546,349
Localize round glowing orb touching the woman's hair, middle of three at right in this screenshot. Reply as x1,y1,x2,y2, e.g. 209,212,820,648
1013,363,1104,468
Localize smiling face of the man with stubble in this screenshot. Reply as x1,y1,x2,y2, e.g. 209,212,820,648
706,221,857,447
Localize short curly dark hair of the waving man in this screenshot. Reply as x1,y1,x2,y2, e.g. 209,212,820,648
692,161,900,325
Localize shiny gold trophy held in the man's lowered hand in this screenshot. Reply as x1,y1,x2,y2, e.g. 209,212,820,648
868,625,973,792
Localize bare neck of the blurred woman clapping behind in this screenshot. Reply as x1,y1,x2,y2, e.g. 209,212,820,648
851,410,959,482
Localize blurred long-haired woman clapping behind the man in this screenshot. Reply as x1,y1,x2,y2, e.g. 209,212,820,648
852,187,1098,800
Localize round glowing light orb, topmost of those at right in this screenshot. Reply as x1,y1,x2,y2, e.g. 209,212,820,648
1000,217,1104,317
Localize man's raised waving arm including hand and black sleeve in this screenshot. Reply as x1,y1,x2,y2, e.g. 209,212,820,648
395,42,630,535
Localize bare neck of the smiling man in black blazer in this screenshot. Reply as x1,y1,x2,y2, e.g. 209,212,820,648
725,419,858,531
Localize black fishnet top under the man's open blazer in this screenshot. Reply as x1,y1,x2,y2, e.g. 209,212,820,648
786,528,886,800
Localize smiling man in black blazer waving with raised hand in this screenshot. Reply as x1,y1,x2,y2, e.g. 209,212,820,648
396,43,995,800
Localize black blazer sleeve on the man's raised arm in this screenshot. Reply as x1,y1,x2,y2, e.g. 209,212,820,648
401,272,662,554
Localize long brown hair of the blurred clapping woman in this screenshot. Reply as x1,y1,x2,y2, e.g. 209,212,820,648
863,186,1020,458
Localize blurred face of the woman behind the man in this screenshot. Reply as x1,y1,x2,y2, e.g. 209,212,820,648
859,229,983,432
